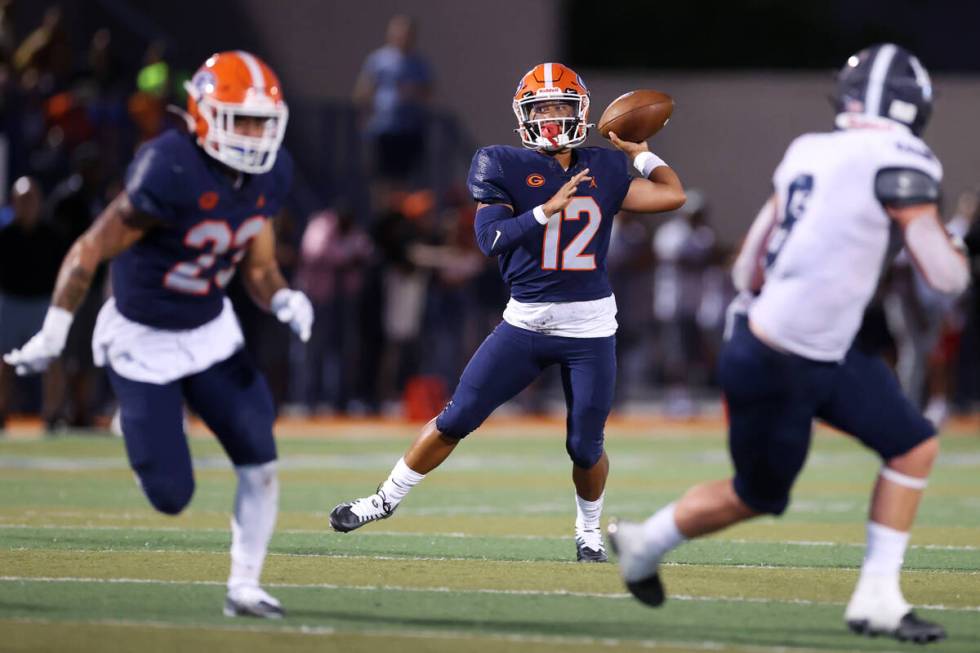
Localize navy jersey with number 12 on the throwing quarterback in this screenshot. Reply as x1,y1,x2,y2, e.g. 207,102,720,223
467,145,632,302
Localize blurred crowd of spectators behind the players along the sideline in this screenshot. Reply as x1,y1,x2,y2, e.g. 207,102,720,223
0,7,980,430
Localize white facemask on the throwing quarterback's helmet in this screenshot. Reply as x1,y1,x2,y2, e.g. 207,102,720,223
514,88,591,152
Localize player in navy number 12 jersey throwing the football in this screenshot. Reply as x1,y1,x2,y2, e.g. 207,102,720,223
330,63,684,562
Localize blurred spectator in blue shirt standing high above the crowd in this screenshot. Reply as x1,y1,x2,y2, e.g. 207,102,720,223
354,15,432,186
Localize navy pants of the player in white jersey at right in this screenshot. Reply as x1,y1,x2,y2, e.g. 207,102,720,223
718,317,936,515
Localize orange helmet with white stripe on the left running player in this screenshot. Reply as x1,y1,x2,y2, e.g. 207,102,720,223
184,50,289,174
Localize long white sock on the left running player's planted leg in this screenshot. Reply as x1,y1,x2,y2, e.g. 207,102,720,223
228,461,279,589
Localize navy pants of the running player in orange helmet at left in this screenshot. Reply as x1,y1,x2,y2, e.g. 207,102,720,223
108,350,276,515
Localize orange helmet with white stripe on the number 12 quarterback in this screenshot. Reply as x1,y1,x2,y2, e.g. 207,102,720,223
514,63,592,152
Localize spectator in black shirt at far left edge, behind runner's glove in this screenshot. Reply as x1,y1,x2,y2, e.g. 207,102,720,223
0,177,65,429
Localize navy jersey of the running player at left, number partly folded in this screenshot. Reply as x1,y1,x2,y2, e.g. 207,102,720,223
111,131,293,330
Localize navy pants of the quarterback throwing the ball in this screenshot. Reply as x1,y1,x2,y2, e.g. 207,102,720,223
436,322,616,469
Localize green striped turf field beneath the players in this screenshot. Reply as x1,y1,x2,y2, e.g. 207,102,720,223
0,426,980,653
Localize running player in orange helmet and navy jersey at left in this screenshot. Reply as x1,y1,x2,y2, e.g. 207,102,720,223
4,51,313,618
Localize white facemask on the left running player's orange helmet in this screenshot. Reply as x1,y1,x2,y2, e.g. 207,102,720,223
185,83,289,174
